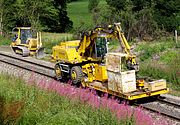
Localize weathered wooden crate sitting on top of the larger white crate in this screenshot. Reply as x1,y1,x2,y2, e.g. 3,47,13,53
106,53,127,72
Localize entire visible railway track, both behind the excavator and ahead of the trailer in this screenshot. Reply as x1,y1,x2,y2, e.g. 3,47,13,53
0,51,180,121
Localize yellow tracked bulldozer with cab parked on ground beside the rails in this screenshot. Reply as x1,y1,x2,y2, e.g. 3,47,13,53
10,27,44,58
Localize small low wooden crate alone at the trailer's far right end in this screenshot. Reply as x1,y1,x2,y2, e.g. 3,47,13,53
148,79,166,91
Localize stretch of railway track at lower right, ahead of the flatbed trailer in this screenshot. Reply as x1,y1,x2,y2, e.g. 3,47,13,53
135,96,180,121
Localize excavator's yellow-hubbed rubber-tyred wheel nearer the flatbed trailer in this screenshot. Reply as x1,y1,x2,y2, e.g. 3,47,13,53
70,66,83,84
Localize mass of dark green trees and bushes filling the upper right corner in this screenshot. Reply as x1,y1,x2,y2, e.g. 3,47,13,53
100,0,180,39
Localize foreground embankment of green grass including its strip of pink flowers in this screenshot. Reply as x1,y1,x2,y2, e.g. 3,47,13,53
0,74,166,125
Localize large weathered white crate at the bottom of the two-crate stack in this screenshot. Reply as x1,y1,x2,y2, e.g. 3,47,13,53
107,70,136,93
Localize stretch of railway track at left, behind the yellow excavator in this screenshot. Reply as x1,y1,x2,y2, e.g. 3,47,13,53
0,51,55,78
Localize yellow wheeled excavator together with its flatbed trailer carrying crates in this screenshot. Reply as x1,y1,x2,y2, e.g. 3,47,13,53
52,23,169,100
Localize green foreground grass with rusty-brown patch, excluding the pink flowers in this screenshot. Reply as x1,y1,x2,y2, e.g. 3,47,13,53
0,74,132,125
